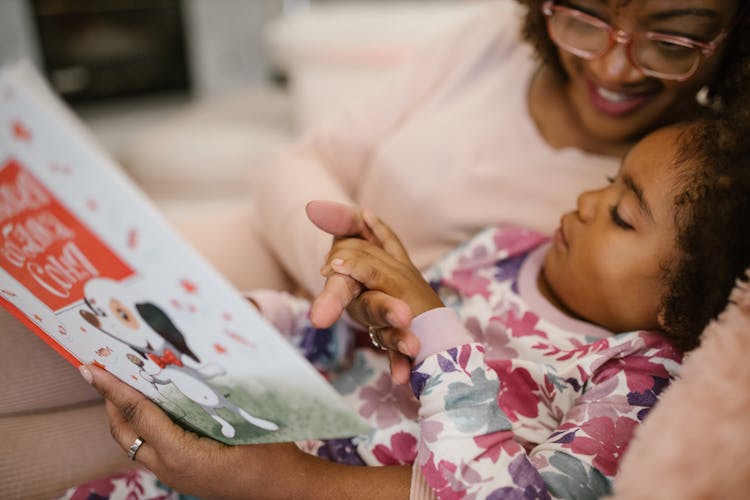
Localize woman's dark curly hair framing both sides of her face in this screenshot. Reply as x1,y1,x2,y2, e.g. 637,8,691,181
517,0,750,106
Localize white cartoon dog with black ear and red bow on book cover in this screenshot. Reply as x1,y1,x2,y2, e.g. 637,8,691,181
79,278,279,438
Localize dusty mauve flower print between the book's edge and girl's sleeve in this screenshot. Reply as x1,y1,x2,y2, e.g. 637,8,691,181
359,373,419,429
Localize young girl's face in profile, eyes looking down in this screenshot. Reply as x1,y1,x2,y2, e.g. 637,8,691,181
540,127,680,332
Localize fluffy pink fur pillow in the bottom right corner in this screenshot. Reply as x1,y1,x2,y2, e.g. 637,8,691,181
614,270,750,500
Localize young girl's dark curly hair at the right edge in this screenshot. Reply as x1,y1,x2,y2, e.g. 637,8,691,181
660,116,750,350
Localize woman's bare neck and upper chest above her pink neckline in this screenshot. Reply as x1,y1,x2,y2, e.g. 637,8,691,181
528,65,632,157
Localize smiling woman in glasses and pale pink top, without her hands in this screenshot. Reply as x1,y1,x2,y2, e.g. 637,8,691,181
246,0,750,293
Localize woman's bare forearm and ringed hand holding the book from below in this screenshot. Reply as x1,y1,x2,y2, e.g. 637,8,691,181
80,365,411,499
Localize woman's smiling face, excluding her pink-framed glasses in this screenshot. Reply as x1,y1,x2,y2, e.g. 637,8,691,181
558,0,738,141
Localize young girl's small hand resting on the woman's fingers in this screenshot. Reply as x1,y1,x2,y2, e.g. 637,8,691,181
321,210,443,317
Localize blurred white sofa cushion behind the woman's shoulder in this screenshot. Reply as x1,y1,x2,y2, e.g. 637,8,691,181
266,0,488,129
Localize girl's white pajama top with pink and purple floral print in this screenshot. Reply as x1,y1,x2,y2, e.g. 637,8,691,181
253,227,681,499
